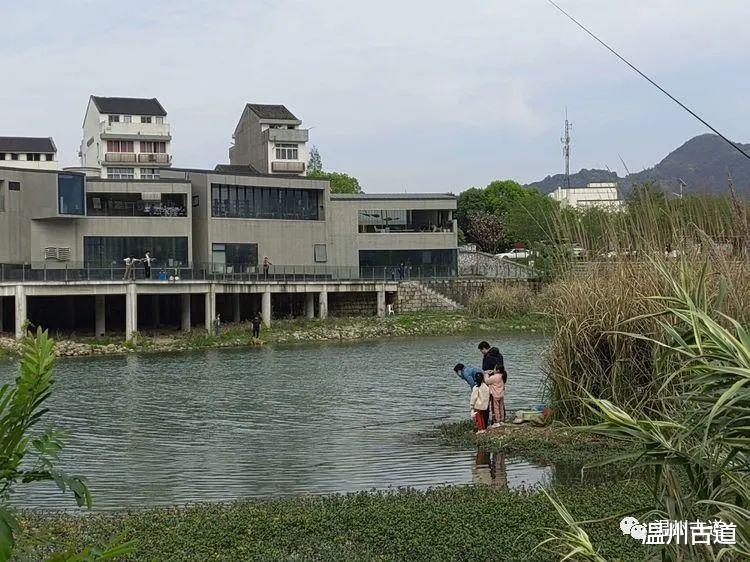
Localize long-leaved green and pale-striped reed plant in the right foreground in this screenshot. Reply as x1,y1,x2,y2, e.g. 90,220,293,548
540,262,750,561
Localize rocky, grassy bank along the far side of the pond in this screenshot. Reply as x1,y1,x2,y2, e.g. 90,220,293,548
0,311,548,356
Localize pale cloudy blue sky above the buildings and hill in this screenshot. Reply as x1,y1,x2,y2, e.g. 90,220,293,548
0,0,750,193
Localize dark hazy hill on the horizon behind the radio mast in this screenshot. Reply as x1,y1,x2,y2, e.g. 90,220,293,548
529,134,750,195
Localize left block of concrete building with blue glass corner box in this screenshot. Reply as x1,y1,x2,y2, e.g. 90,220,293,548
0,168,192,270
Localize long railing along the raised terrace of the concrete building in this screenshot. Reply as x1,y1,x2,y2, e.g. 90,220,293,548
0,261,457,283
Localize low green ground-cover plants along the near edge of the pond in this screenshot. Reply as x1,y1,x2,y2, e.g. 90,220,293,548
23,482,648,561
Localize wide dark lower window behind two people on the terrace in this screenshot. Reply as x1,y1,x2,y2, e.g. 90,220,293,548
83,236,188,267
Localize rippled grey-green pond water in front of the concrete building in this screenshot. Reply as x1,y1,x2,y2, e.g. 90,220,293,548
0,334,554,510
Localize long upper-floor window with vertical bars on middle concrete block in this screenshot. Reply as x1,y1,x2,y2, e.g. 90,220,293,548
211,183,322,220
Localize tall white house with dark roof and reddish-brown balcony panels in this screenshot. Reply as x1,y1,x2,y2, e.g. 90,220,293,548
79,96,172,179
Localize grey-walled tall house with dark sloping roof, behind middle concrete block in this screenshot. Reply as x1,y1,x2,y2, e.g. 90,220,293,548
229,103,309,175
